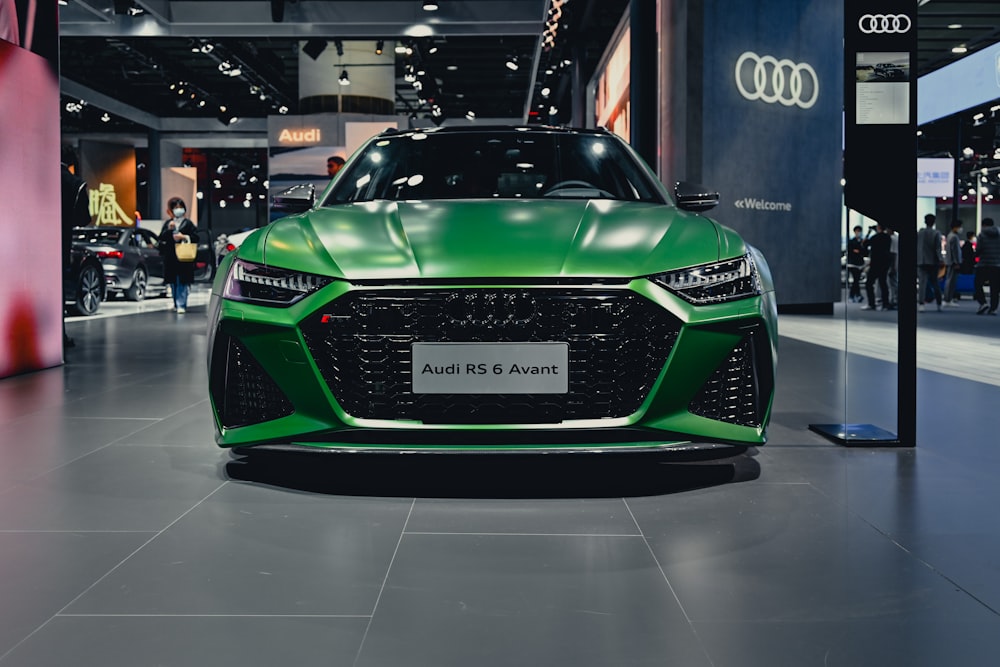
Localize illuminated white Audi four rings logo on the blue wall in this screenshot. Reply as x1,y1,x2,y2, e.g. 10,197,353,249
736,51,819,109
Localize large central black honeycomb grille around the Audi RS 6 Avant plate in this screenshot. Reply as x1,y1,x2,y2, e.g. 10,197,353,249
301,288,680,424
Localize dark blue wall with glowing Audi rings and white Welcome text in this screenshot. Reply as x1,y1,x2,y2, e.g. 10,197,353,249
672,0,843,304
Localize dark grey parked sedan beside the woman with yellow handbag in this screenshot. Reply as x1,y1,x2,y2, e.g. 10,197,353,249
73,227,166,301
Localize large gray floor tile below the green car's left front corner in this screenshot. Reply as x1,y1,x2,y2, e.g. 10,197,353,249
67,483,412,614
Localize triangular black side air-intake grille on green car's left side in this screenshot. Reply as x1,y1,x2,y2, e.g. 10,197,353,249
210,332,294,428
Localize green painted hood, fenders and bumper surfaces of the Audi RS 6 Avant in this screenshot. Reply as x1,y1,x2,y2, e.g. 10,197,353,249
209,126,777,452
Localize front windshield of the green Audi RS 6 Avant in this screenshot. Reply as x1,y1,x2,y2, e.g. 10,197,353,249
323,130,663,206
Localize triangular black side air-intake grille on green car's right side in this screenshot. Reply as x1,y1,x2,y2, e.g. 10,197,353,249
688,333,773,427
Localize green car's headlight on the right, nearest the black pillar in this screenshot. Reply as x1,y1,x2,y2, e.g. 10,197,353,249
650,253,762,306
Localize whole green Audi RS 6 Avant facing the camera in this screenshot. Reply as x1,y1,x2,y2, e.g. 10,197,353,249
209,127,776,452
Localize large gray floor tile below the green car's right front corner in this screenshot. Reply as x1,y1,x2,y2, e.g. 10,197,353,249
629,484,980,622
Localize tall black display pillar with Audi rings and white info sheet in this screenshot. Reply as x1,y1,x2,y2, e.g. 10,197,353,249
844,0,918,447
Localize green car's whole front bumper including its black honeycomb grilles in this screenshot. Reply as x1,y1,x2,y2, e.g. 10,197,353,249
209,279,776,451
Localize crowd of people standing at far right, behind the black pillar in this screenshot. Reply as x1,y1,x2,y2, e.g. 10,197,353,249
846,213,1000,315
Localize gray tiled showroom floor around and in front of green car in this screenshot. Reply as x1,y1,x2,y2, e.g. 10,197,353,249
0,294,1000,667
